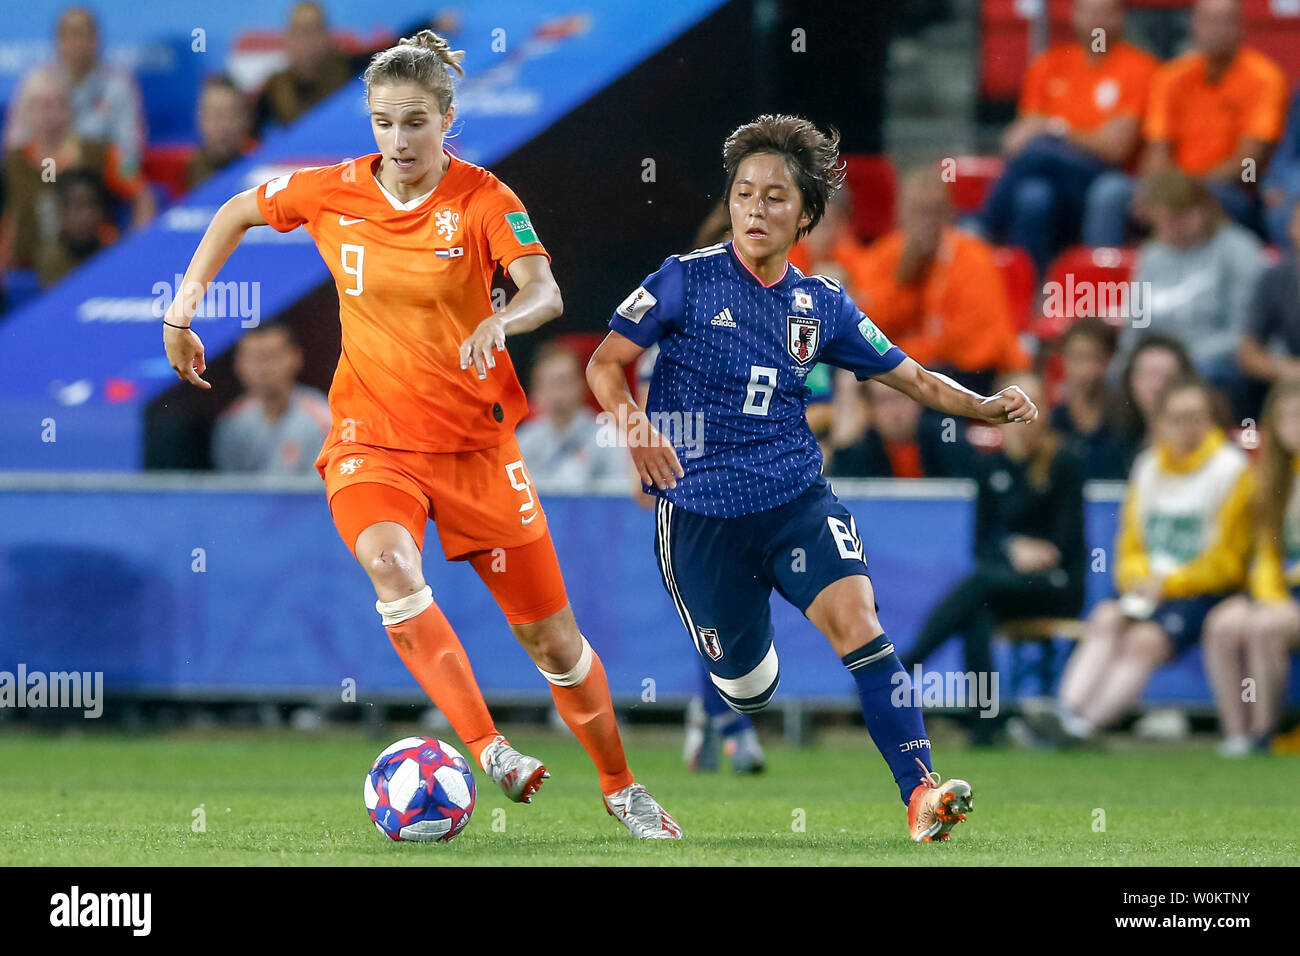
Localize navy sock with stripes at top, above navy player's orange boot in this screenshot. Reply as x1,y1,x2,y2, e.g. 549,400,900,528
840,635,932,804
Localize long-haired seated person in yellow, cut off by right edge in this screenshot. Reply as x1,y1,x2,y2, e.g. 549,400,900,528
1204,378,1300,757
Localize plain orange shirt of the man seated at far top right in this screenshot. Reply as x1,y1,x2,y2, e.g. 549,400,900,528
1143,48,1287,176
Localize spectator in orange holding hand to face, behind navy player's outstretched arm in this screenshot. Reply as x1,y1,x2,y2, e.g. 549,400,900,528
852,166,1028,392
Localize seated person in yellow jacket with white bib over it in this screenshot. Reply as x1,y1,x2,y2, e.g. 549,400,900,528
1040,378,1253,743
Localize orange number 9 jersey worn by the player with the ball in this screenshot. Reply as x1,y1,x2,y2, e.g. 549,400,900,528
257,151,550,451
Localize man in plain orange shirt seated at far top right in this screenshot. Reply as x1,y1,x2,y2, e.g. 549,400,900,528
1093,0,1287,246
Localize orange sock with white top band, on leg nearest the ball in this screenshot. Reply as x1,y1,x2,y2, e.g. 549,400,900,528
374,585,497,763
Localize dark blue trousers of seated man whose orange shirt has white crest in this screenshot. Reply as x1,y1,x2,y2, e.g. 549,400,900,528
982,135,1110,276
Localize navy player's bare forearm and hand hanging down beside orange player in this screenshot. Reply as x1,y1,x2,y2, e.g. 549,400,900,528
586,332,686,489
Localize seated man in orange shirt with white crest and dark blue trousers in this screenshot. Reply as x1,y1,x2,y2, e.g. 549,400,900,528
982,0,1157,273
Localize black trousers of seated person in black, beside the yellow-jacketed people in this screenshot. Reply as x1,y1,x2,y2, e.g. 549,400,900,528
901,564,1083,745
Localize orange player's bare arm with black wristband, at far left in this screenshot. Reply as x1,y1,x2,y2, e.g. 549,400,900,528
163,189,267,389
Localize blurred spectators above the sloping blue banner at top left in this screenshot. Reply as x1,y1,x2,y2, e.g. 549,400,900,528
0,0,426,297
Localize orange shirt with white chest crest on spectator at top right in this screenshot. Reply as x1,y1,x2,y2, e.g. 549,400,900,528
1019,42,1160,133
